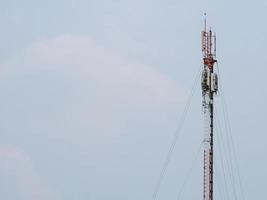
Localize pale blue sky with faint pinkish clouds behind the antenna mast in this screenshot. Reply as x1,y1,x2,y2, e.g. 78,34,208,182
0,0,267,200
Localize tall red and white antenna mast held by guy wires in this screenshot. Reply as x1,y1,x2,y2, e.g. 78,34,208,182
201,13,218,200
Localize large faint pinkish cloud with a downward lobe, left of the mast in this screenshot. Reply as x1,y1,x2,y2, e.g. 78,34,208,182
19,36,186,136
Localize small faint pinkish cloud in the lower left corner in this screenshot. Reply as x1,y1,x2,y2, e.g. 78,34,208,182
0,146,58,200
